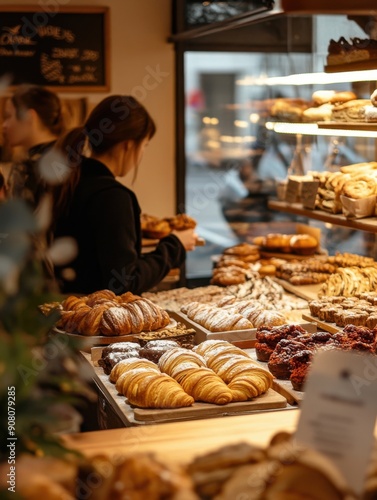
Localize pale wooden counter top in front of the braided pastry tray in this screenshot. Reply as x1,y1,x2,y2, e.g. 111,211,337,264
64,409,300,463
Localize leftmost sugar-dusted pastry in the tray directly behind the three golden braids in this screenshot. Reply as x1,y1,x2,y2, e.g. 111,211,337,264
184,302,253,332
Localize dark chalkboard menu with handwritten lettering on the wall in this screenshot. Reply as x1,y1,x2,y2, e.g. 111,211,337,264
0,6,109,92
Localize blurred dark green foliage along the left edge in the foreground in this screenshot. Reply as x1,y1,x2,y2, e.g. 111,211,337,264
0,198,93,461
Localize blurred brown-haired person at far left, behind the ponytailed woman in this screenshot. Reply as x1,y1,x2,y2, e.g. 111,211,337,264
2,85,64,210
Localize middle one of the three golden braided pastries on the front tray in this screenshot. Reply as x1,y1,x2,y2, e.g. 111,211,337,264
158,347,233,405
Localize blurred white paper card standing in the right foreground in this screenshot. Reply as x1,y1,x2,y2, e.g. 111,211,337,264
296,350,377,494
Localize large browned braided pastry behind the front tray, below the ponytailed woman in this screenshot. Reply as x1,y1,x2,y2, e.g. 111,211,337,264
57,290,170,336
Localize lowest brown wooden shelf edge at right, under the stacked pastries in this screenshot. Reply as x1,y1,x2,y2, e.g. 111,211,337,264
268,201,377,233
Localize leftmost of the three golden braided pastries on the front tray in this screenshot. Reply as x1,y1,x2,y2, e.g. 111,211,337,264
110,358,194,408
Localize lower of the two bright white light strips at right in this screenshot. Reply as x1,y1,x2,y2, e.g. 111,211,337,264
266,122,377,137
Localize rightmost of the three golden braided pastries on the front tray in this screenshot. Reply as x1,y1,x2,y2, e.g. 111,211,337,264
194,341,273,401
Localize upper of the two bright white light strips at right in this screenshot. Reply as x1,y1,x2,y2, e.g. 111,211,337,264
236,69,377,86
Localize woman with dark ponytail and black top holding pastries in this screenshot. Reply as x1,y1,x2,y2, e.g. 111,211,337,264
54,95,196,294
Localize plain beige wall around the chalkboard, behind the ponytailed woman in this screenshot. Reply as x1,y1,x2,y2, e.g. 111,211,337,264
0,0,175,216
